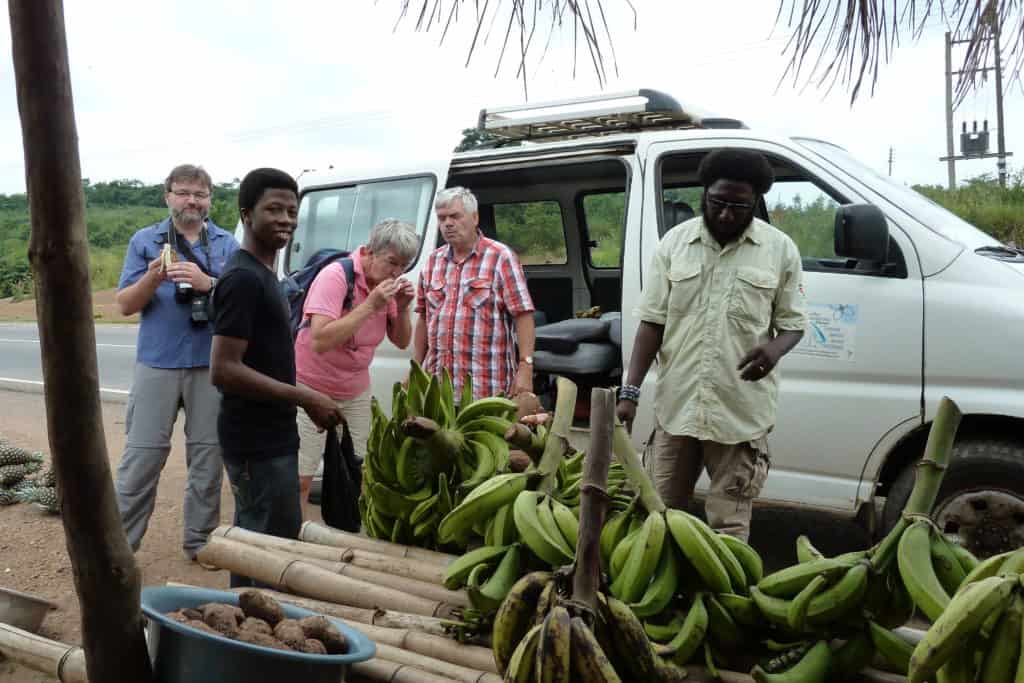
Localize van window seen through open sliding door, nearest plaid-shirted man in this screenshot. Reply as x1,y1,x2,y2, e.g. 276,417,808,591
494,201,568,265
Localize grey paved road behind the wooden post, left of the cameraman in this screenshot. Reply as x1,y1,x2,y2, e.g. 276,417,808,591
0,323,138,396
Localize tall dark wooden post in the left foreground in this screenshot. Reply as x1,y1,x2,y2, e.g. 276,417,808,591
8,0,152,683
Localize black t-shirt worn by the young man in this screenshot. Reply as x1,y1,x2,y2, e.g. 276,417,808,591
213,249,299,460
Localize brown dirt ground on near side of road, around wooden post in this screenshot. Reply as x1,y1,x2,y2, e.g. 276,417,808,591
0,391,319,683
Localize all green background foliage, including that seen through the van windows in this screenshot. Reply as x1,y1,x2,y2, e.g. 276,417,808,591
0,172,1024,297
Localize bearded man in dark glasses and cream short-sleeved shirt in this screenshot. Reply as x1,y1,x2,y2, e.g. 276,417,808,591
615,150,807,541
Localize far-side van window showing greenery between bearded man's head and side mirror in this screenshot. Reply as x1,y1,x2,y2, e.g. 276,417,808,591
765,180,839,259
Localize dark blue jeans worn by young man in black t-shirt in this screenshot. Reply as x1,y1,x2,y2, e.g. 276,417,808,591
224,453,302,588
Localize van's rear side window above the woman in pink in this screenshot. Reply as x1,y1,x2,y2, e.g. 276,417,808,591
285,176,436,271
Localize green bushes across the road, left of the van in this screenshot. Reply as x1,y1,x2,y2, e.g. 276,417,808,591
0,178,239,297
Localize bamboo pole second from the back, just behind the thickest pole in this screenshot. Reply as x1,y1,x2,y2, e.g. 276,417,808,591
211,525,444,586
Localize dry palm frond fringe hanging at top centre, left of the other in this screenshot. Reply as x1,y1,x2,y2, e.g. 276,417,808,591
394,0,637,95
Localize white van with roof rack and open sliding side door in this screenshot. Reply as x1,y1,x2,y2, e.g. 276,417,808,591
280,90,1024,554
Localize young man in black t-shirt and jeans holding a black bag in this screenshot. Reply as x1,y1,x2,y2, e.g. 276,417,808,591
210,168,341,587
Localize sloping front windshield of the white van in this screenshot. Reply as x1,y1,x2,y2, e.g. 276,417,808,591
794,137,999,249
